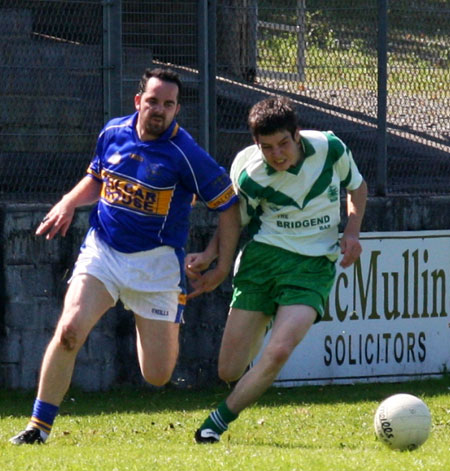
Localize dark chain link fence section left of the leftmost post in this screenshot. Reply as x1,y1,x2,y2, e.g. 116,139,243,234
0,0,103,200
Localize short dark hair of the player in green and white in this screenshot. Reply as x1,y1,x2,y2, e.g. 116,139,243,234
248,97,299,140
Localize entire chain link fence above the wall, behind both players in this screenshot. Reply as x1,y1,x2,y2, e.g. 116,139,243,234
0,0,450,201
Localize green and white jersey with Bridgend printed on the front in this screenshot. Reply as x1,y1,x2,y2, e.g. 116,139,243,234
230,131,363,260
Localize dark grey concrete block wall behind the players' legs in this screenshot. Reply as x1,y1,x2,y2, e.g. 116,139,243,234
0,197,450,391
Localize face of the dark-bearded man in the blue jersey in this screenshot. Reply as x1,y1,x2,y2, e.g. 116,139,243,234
134,77,180,141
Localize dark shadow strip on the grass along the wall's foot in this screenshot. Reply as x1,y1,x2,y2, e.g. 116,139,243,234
0,374,450,418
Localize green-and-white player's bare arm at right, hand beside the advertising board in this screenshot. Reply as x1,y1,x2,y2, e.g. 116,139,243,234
340,181,367,268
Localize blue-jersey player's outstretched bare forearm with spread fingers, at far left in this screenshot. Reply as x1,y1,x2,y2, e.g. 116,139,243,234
36,176,102,240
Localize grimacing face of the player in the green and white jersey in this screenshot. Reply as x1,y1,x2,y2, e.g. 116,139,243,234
256,130,301,172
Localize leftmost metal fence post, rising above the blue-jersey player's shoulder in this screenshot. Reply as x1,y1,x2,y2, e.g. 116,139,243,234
103,0,122,123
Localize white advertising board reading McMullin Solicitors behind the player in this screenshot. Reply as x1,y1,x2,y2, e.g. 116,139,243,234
256,231,450,386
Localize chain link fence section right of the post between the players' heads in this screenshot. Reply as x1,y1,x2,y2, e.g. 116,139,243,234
217,0,450,195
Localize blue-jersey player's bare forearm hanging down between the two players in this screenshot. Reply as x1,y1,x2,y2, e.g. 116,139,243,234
186,204,241,299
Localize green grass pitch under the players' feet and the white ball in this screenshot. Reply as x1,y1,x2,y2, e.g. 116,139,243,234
0,374,450,471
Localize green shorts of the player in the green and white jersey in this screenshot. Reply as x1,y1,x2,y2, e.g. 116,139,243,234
231,241,336,322
